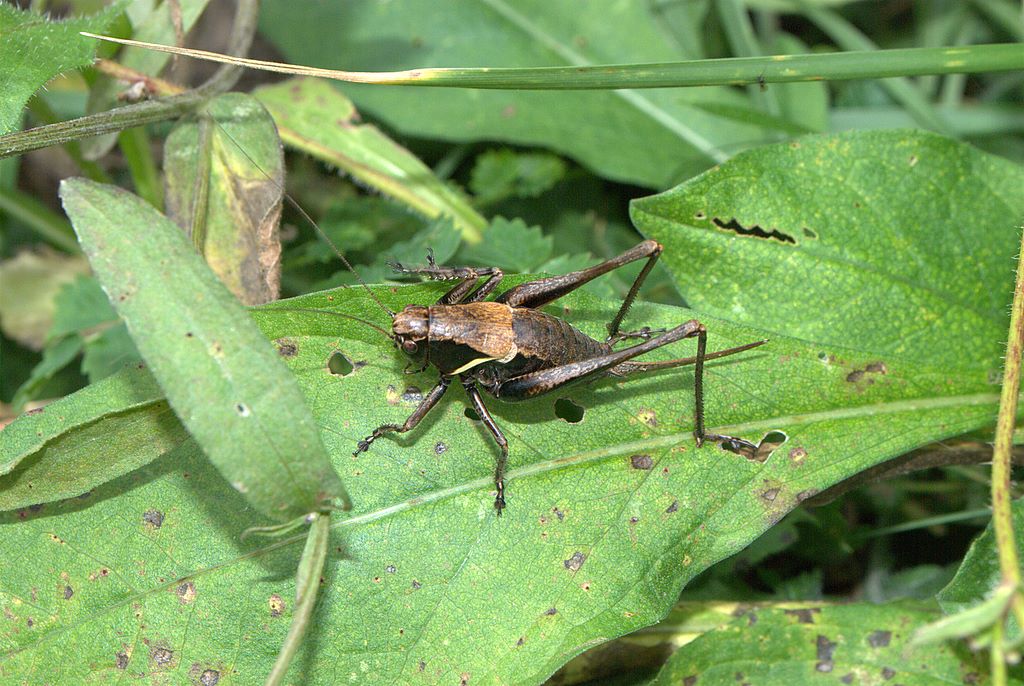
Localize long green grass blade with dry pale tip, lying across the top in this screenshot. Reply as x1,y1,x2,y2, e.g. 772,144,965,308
81,34,1024,90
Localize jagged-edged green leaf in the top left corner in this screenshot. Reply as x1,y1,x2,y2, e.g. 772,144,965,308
0,3,123,135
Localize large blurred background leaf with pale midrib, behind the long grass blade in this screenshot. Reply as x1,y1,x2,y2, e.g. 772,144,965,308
260,0,764,188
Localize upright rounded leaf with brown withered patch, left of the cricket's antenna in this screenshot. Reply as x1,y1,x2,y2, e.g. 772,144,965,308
164,93,285,305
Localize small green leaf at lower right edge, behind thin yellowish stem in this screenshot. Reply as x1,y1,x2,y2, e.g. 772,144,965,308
937,500,1024,641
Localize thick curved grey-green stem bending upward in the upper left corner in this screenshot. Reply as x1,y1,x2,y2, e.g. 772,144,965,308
0,0,259,158
